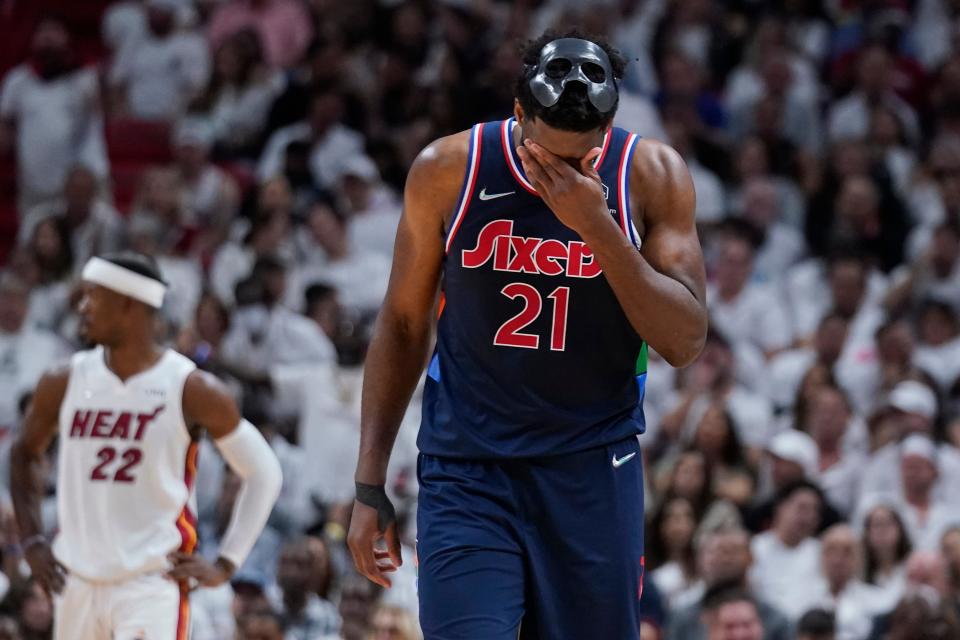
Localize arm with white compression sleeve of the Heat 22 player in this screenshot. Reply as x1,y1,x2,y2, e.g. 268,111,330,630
169,371,281,587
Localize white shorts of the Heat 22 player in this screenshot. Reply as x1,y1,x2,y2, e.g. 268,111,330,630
53,573,190,640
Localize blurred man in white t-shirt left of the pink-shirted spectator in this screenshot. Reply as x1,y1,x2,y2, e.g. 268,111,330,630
110,0,210,121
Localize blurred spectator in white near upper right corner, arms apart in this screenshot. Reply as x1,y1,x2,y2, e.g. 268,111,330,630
828,44,920,142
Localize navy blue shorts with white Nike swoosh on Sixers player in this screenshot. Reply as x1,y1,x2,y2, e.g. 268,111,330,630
417,437,643,640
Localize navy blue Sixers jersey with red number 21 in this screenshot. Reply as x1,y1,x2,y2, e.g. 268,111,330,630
418,118,646,458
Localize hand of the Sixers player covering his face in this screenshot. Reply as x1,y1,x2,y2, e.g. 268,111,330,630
517,138,609,235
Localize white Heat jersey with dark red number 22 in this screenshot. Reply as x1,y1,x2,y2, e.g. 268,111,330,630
53,347,197,581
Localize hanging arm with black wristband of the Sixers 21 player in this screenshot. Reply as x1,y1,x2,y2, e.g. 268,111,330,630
347,127,469,586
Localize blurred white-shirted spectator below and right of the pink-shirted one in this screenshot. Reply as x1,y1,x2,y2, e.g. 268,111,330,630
257,87,363,188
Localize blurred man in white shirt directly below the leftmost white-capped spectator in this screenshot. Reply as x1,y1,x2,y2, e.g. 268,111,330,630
751,481,823,620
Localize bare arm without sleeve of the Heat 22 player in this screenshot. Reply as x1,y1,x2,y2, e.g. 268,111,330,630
10,366,70,593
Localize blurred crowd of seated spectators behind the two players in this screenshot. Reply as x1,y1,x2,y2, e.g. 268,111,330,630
0,0,960,640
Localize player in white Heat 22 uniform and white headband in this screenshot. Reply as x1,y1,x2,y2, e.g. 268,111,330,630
10,253,281,640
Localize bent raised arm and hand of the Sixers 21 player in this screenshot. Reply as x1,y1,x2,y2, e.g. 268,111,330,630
518,140,707,367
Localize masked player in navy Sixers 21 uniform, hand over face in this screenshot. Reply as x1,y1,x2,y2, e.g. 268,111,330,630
349,33,707,640
